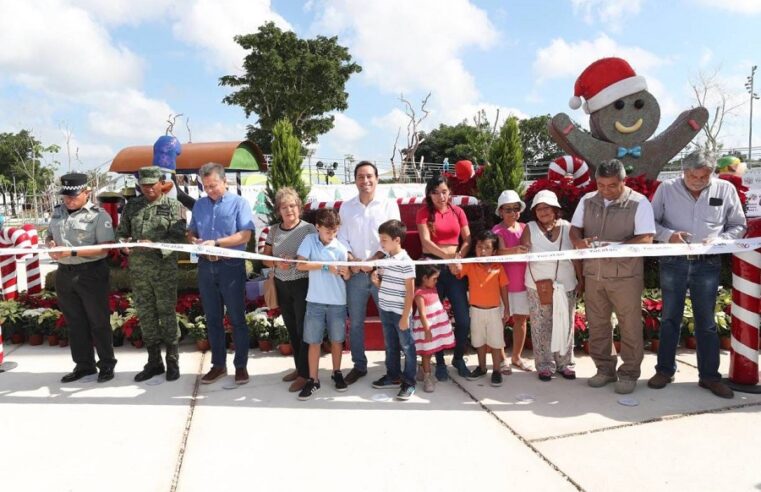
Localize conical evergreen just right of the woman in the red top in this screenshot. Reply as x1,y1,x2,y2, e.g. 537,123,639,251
477,116,523,206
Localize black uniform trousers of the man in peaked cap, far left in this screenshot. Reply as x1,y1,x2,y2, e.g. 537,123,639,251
55,260,116,370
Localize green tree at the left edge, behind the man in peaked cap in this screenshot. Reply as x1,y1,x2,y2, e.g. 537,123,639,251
0,130,60,215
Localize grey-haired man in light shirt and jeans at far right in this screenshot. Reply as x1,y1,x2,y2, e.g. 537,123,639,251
647,149,746,398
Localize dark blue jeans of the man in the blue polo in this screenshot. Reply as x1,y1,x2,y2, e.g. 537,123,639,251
198,258,250,369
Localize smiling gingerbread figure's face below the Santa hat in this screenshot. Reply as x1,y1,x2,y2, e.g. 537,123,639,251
589,90,661,147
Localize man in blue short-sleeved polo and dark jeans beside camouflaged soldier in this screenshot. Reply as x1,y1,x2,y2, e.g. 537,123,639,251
188,163,254,384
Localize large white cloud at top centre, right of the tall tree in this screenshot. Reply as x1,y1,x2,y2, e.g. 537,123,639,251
315,0,498,114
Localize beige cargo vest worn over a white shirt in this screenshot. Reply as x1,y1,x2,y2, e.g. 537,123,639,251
583,186,644,279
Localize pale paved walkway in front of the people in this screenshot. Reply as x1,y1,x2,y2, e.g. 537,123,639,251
0,345,761,492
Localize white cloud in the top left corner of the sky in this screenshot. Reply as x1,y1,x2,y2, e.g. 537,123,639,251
0,0,142,94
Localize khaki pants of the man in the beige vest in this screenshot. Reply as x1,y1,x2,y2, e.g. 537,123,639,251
584,276,644,380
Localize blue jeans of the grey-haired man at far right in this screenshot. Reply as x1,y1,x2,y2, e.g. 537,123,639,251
655,255,721,381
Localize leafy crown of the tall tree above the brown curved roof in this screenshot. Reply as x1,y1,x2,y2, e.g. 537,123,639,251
219,22,362,153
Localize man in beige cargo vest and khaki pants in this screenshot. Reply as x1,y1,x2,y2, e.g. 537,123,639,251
570,159,655,394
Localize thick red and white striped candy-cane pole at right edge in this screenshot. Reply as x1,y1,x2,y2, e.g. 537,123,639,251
728,219,761,393
